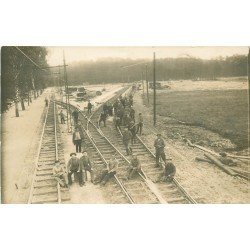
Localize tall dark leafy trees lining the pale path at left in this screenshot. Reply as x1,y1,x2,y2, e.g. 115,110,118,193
1,46,50,116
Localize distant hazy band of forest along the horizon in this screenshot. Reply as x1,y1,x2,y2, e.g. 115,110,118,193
65,55,247,85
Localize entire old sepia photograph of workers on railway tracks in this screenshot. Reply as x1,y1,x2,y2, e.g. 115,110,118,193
1,46,250,205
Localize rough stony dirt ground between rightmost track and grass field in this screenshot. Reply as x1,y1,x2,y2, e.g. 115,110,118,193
134,86,250,203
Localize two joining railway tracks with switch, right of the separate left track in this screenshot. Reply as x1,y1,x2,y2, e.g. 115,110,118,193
56,85,196,204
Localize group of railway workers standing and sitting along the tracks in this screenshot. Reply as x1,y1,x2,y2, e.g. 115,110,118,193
53,90,176,187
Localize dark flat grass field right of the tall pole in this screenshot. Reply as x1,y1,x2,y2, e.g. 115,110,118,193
146,90,248,149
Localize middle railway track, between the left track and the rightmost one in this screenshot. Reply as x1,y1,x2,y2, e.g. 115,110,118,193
57,90,165,204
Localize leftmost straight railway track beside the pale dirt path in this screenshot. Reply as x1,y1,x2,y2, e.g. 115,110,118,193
28,95,70,204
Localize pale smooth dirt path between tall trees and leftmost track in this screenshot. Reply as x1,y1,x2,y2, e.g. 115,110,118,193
1,89,50,203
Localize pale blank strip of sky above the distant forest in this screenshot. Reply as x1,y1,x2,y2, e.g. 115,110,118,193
47,46,248,66
